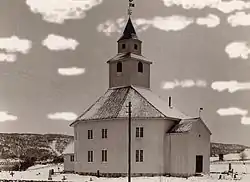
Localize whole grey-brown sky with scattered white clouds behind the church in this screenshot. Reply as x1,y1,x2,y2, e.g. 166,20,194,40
0,0,250,146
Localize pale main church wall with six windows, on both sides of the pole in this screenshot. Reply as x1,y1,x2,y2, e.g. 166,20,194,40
75,119,173,173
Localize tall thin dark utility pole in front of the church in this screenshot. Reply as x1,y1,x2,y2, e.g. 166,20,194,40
128,102,131,182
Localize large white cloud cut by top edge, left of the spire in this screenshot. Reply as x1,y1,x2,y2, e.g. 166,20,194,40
26,0,102,24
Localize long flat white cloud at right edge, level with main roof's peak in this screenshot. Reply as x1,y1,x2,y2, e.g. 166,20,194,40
211,81,250,93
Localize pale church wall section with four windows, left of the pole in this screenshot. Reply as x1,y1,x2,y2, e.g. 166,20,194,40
75,120,127,173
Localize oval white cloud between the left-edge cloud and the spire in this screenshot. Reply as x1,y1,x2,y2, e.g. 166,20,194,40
42,34,79,51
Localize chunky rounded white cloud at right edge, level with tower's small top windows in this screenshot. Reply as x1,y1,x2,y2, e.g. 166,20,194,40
225,41,250,59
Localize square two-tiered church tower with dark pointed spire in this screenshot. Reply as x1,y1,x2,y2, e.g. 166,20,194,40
107,17,152,89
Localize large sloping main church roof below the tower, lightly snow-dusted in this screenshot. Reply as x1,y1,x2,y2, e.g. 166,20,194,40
71,86,189,125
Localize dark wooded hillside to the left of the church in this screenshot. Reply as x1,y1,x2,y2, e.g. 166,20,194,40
0,133,73,161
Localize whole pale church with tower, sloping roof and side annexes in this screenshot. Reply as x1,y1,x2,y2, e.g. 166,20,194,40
65,18,211,176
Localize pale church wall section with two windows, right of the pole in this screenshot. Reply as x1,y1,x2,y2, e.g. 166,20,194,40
132,119,174,173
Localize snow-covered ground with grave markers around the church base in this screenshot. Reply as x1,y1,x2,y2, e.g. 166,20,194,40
0,162,250,182
